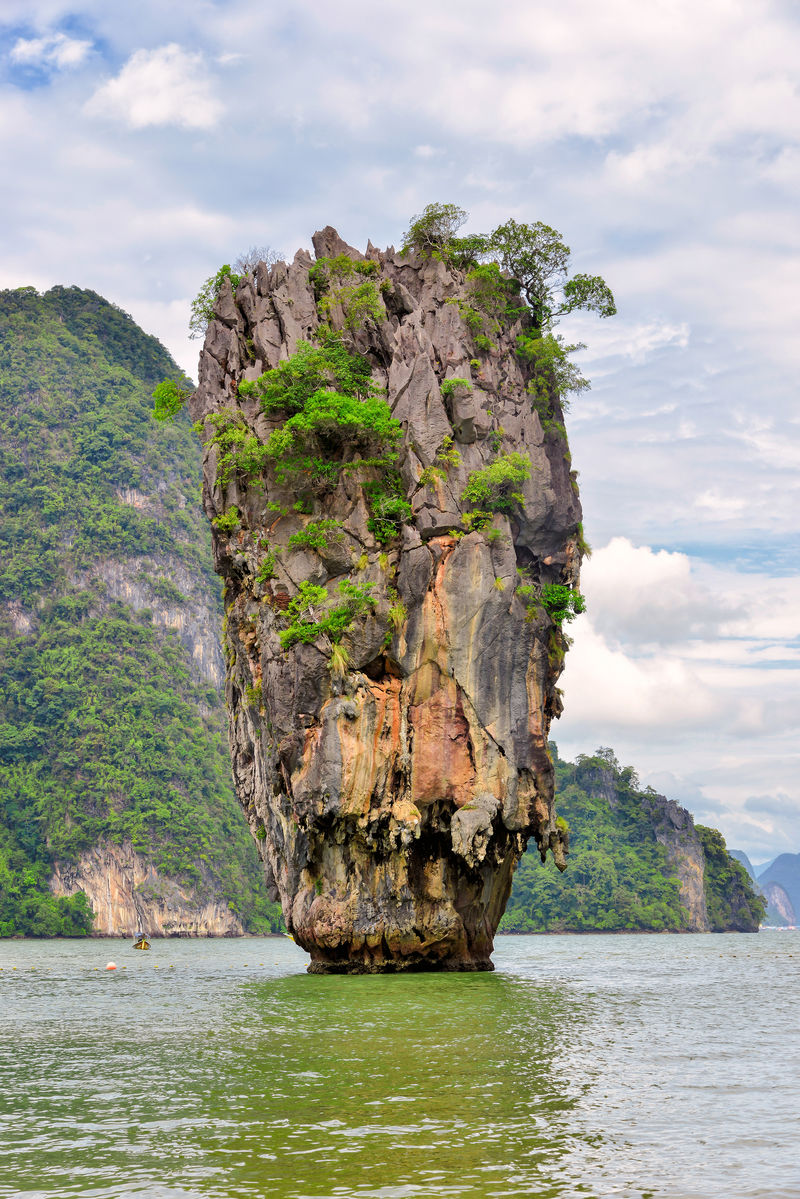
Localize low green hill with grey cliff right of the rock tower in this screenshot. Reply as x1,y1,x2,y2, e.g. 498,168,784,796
500,745,764,933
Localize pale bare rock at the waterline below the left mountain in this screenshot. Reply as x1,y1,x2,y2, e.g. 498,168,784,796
50,842,243,936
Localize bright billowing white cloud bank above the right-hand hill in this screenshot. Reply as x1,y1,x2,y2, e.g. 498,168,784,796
553,538,800,856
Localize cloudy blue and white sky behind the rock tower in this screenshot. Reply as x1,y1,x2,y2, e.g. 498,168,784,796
0,0,800,862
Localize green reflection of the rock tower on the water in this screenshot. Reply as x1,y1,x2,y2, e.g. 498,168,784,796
195,975,594,1199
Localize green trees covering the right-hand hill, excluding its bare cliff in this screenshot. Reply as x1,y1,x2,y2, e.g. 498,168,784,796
499,743,757,933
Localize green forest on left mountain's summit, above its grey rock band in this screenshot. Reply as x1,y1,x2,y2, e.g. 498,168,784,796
0,288,206,607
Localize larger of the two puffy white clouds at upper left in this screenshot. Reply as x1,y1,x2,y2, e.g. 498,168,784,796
85,42,222,129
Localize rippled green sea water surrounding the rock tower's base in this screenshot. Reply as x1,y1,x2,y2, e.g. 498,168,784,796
0,933,800,1199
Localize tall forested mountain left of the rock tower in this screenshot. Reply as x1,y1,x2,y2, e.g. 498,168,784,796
0,288,279,936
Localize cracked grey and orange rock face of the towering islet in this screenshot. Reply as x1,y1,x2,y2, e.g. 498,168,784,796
192,228,581,970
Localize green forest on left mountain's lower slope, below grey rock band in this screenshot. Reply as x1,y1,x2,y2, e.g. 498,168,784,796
0,604,272,906
